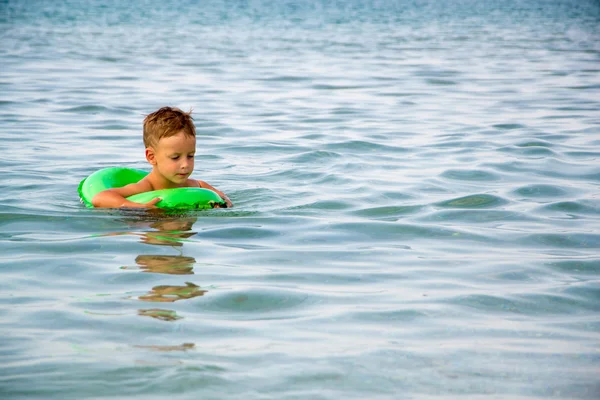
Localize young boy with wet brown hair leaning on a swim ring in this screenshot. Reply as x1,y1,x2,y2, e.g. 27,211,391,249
92,107,233,208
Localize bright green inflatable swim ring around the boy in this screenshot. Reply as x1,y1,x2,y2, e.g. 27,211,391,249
78,167,226,210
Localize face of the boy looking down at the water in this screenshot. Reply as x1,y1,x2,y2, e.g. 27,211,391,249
146,131,196,185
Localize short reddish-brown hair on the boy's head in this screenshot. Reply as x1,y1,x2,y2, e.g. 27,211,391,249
144,107,196,147
